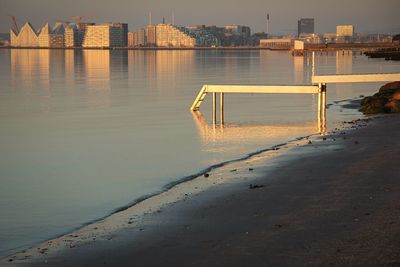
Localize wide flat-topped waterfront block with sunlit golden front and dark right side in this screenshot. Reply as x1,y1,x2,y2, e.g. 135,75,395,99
82,23,128,48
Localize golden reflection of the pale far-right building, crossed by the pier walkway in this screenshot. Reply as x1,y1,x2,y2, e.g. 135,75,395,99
336,50,353,99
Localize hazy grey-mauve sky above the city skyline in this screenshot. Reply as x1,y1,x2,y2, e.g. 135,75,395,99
0,0,400,34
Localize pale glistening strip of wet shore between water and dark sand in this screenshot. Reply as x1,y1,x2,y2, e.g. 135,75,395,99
0,108,382,264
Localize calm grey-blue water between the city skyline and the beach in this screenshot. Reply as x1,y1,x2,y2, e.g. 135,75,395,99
0,50,400,256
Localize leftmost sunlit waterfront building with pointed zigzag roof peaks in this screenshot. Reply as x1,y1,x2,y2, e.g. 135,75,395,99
10,22,39,47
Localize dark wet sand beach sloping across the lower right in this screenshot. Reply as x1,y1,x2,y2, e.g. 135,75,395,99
3,115,400,266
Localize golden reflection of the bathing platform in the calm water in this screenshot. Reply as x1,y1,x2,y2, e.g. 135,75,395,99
192,111,320,144
